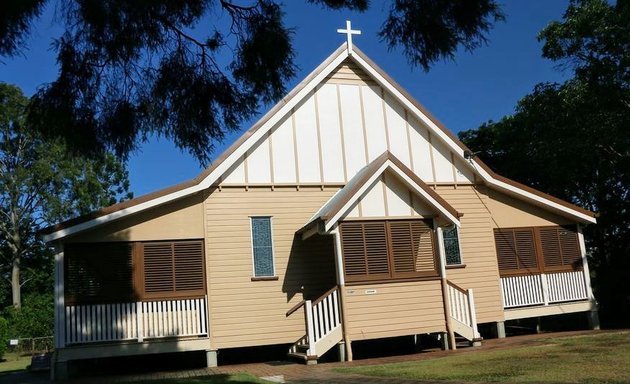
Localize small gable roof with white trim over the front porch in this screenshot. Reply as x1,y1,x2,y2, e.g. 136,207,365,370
298,151,462,237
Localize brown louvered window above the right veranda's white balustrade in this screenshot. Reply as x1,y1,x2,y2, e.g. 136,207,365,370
494,227,582,275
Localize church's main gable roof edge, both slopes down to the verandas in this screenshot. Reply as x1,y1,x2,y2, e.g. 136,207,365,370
42,43,596,242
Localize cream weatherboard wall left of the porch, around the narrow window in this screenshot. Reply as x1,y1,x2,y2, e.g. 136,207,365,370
205,187,338,349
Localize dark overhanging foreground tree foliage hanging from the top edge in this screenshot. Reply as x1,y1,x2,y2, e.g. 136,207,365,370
0,0,503,163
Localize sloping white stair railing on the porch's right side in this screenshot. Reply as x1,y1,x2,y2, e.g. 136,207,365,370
446,281,481,345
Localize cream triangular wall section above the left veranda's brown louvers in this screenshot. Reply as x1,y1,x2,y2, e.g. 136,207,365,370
65,193,204,243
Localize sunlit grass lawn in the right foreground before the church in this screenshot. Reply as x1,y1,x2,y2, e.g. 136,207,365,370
335,331,630,383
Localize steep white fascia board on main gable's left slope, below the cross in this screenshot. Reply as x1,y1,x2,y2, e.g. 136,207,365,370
200,50,348,188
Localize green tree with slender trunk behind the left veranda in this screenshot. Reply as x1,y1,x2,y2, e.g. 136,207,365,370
0,83,130,308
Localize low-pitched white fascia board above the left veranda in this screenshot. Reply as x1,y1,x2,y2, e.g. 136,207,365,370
42,185,203,243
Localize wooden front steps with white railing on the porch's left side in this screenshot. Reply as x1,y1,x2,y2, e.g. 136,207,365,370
287,287,343,364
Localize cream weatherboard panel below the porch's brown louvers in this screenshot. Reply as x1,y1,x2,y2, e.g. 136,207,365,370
345,280,446,340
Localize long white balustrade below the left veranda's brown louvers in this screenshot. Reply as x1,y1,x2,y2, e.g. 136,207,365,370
65,298,208,344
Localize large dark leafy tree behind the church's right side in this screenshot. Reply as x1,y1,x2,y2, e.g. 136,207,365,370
460,0,630,326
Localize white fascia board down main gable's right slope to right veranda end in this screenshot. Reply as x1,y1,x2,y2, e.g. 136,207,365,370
352,55,597,223
